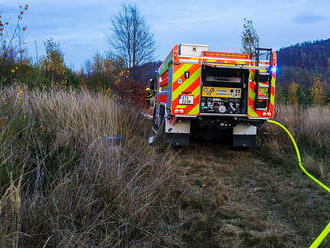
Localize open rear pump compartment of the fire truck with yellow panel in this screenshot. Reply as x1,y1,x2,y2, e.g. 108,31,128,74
200,65,249,115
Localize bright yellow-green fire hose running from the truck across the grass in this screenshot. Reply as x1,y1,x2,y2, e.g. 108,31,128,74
268,120,330,248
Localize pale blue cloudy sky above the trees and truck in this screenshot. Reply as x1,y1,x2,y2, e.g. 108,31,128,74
0,0,330,69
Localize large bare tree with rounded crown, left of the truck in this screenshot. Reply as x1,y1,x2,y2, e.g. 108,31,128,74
107,4,156,77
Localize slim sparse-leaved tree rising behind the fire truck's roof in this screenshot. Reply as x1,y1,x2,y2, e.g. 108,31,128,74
242,19,259,57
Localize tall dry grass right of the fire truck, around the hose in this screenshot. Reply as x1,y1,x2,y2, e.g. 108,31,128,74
262,102,330,185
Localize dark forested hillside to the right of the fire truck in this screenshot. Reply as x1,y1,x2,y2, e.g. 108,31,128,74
277,39,330,105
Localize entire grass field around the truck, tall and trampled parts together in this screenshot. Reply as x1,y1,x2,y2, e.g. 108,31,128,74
0,87,330,248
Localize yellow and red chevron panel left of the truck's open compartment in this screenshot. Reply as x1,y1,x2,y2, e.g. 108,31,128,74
172,61,201,115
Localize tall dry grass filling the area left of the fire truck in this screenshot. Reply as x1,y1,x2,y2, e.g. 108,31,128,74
0,87,181,247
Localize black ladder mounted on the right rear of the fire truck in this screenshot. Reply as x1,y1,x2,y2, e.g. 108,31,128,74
254,48,273,111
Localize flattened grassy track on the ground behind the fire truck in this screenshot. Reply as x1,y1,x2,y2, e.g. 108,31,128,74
174,142,330,247
